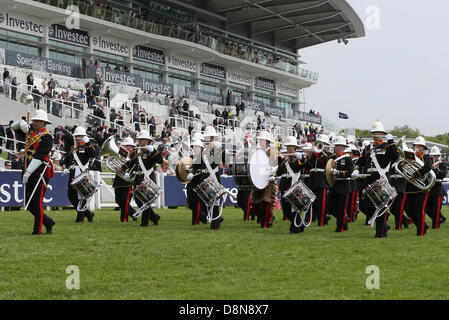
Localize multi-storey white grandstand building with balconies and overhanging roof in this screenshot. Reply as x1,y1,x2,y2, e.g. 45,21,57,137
0,0,364,139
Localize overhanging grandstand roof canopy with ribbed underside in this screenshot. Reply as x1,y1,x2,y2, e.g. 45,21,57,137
156,0,365,53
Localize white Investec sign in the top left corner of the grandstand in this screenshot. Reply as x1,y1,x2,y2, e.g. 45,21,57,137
0,12,44,37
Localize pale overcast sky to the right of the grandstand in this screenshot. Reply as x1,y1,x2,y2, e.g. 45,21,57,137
300,0,449,135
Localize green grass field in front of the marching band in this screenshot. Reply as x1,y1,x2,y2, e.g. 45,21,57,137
0,208,449,299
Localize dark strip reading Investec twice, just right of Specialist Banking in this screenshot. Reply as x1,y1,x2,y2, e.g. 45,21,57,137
89,66,174,95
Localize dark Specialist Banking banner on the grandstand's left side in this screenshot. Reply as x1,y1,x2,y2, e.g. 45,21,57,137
6,50,81,78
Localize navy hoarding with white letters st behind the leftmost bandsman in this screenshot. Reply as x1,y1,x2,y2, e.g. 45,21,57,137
0,170,71,207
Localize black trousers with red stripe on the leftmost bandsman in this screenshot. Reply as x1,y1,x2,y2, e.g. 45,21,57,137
25,167,54,234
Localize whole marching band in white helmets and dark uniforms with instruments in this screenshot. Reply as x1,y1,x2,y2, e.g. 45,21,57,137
15,110,447,238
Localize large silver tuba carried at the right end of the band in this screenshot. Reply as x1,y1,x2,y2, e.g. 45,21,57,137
393,136,436,191
